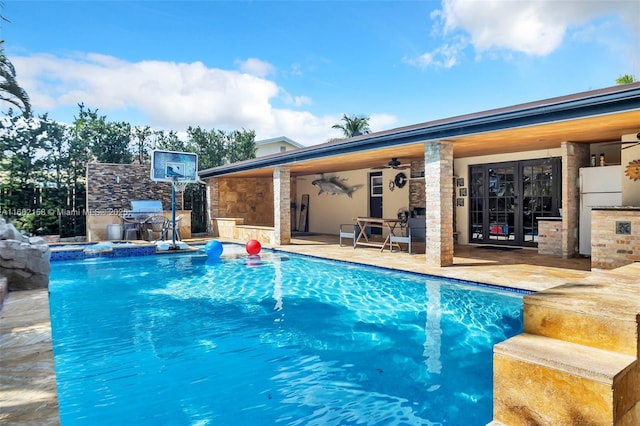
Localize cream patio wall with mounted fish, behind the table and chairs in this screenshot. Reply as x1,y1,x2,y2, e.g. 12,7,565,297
296,169,409,235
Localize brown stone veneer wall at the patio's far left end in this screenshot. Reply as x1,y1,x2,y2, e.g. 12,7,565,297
216,177,274,226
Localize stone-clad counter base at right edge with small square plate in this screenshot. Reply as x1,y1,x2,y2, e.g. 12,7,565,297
591,207,640,269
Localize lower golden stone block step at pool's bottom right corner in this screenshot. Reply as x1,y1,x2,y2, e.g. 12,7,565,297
493,333,640,426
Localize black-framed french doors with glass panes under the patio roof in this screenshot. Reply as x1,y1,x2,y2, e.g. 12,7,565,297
469,158,562,247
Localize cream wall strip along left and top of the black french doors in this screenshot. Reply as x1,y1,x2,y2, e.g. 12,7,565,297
453,148,562,244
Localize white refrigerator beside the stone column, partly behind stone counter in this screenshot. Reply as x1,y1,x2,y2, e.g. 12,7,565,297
579,166,622,256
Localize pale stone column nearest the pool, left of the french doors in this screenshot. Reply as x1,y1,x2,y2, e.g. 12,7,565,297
424,142,453,266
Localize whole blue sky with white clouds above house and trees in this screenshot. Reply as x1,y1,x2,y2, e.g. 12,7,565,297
0,0,640,146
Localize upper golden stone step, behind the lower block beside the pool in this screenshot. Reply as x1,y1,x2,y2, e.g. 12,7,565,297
523,284,640,357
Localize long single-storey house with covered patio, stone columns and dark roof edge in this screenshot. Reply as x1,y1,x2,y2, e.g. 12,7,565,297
200,83,640,266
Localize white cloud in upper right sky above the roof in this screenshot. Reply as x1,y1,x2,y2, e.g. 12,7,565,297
405,0,640,68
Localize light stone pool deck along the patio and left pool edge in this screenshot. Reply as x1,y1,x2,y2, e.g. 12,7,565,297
0,235,640,425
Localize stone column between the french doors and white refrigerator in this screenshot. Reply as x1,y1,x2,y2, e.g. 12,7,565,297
560,142,589,259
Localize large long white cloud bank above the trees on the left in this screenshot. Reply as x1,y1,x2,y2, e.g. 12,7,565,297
10,54,350,145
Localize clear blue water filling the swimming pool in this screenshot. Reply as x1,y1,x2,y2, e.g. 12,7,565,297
50,245,522,426
